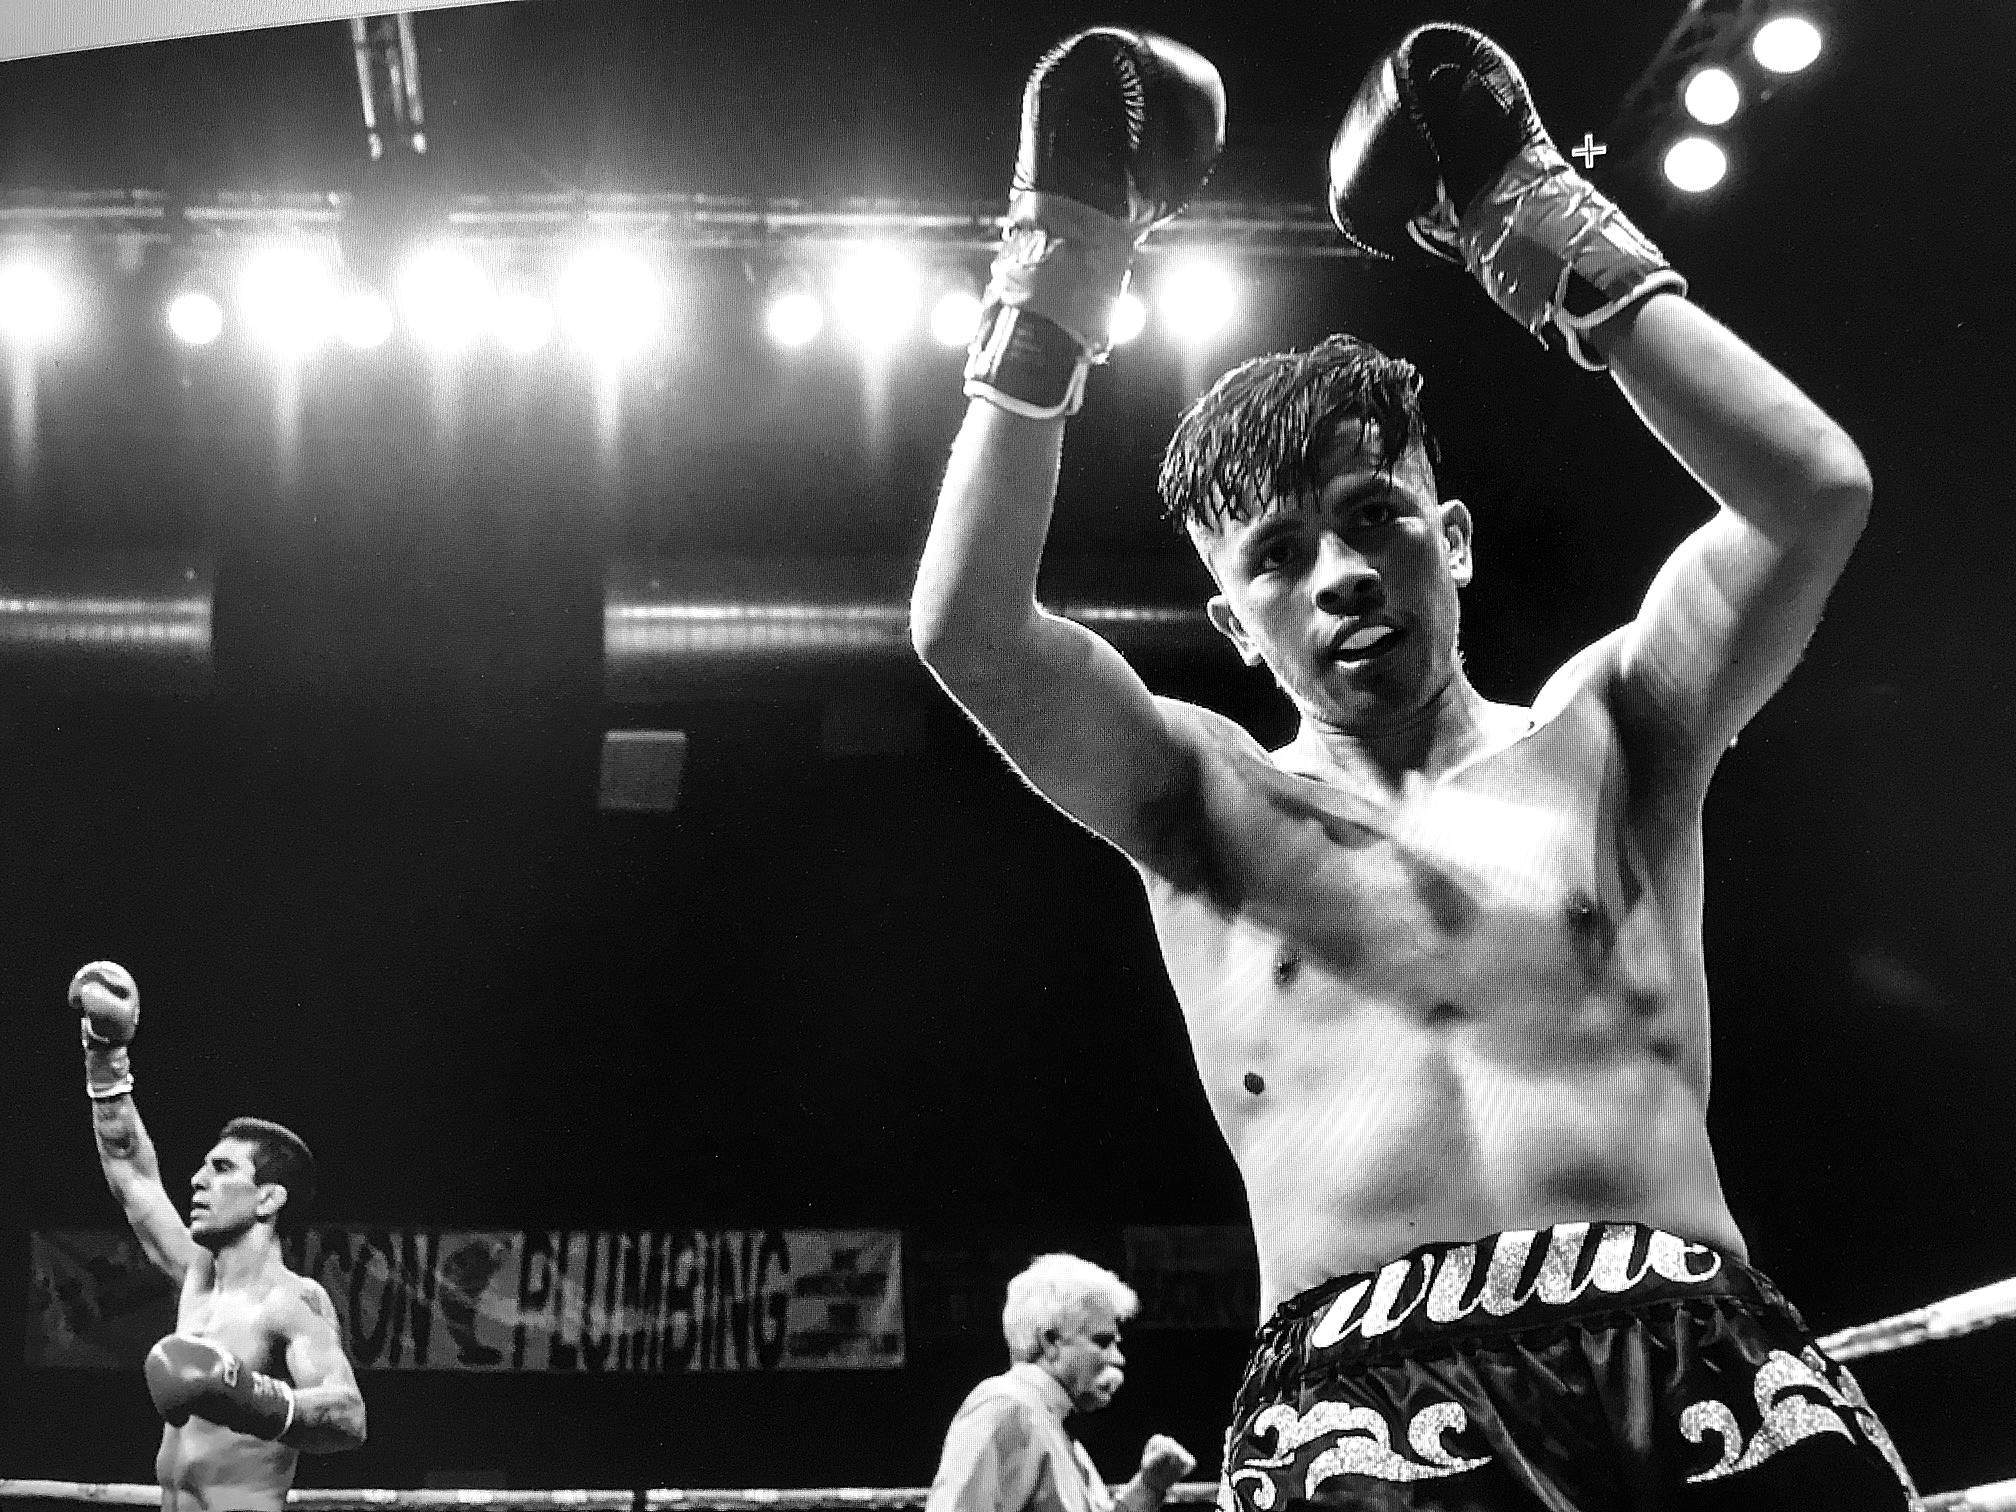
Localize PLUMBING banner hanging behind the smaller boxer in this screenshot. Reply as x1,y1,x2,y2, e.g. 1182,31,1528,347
28,1228,905,1373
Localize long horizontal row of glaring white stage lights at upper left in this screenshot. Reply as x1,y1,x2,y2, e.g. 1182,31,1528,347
0,244,1240,361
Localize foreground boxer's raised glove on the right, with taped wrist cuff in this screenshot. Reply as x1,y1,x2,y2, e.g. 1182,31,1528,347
1331,22,1687,373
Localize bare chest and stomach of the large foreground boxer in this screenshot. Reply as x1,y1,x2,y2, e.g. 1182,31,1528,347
1143,669,1744,1310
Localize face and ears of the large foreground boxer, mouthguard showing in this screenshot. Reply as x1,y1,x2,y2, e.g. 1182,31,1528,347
1200,419,1472,734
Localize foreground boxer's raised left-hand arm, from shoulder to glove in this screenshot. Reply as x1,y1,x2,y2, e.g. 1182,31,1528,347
911,26,1226,859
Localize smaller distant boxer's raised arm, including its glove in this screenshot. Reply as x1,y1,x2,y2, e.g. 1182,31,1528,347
69,962,202,1282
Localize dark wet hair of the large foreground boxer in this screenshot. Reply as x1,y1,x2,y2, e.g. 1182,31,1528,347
1157,335,1441,532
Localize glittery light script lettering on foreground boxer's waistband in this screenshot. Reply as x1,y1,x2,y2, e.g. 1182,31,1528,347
1308,1224,1722,1349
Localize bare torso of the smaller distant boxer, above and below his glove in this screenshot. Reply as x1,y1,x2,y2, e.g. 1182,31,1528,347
153,1256,300,1512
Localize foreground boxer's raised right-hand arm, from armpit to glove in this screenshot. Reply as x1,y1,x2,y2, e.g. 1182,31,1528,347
1331,22,1869,806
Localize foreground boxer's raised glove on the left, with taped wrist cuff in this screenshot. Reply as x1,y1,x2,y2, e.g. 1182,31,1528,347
966,26,1226,419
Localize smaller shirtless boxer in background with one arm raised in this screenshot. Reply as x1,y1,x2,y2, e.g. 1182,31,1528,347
71,962,365,1512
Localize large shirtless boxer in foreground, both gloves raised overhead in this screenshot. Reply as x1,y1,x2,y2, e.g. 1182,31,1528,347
911,26,1909,1512
